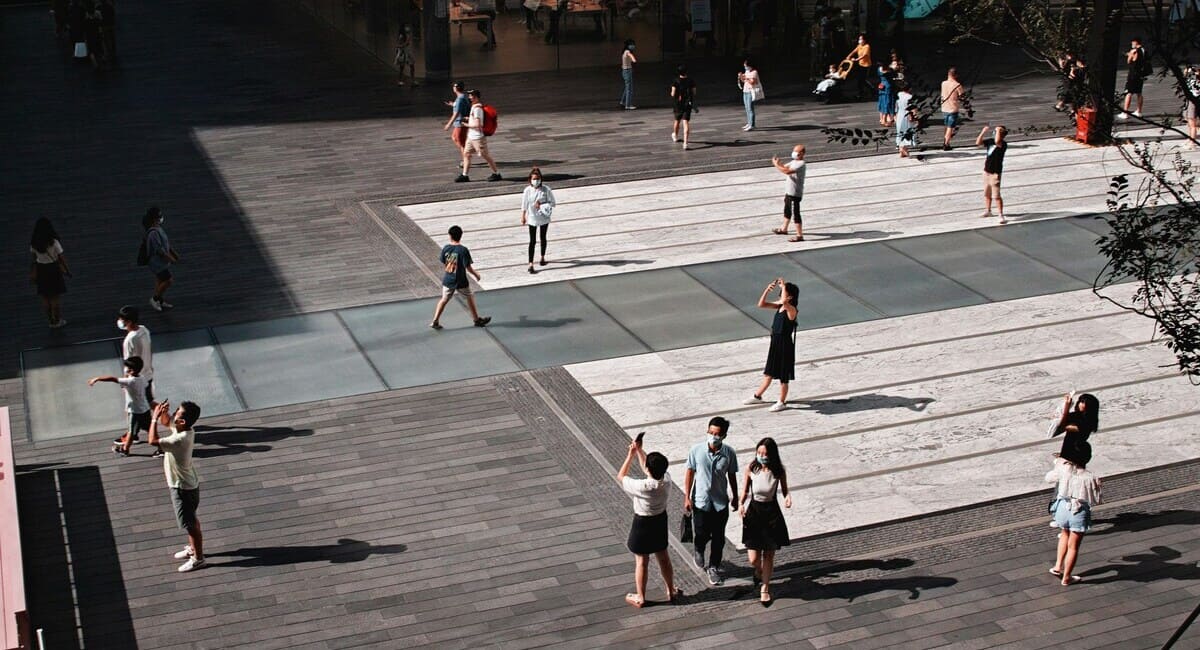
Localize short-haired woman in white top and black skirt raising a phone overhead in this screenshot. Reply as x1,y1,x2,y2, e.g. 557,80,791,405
617,441,680,608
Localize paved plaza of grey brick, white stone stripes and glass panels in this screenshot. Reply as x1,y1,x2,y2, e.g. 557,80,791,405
0,0,1200,650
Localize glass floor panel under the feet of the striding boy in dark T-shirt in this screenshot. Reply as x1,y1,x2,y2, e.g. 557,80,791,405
338,299,521,389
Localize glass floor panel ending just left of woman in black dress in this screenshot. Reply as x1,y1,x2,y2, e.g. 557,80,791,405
575,269,766,350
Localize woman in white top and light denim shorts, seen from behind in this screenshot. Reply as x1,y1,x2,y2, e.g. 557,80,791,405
1045,439,1100,586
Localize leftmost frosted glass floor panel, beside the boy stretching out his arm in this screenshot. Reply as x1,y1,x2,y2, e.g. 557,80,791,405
22,341,128,443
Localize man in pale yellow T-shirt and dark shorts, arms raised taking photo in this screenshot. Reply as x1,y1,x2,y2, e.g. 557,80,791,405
149,402,208,573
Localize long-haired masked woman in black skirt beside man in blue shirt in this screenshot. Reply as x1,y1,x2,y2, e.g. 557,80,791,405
738,438,792,604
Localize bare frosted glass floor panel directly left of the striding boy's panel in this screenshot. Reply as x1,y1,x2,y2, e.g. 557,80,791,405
212,312,385,409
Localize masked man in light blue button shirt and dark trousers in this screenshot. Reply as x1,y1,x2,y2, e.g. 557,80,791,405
683,416,738,585
